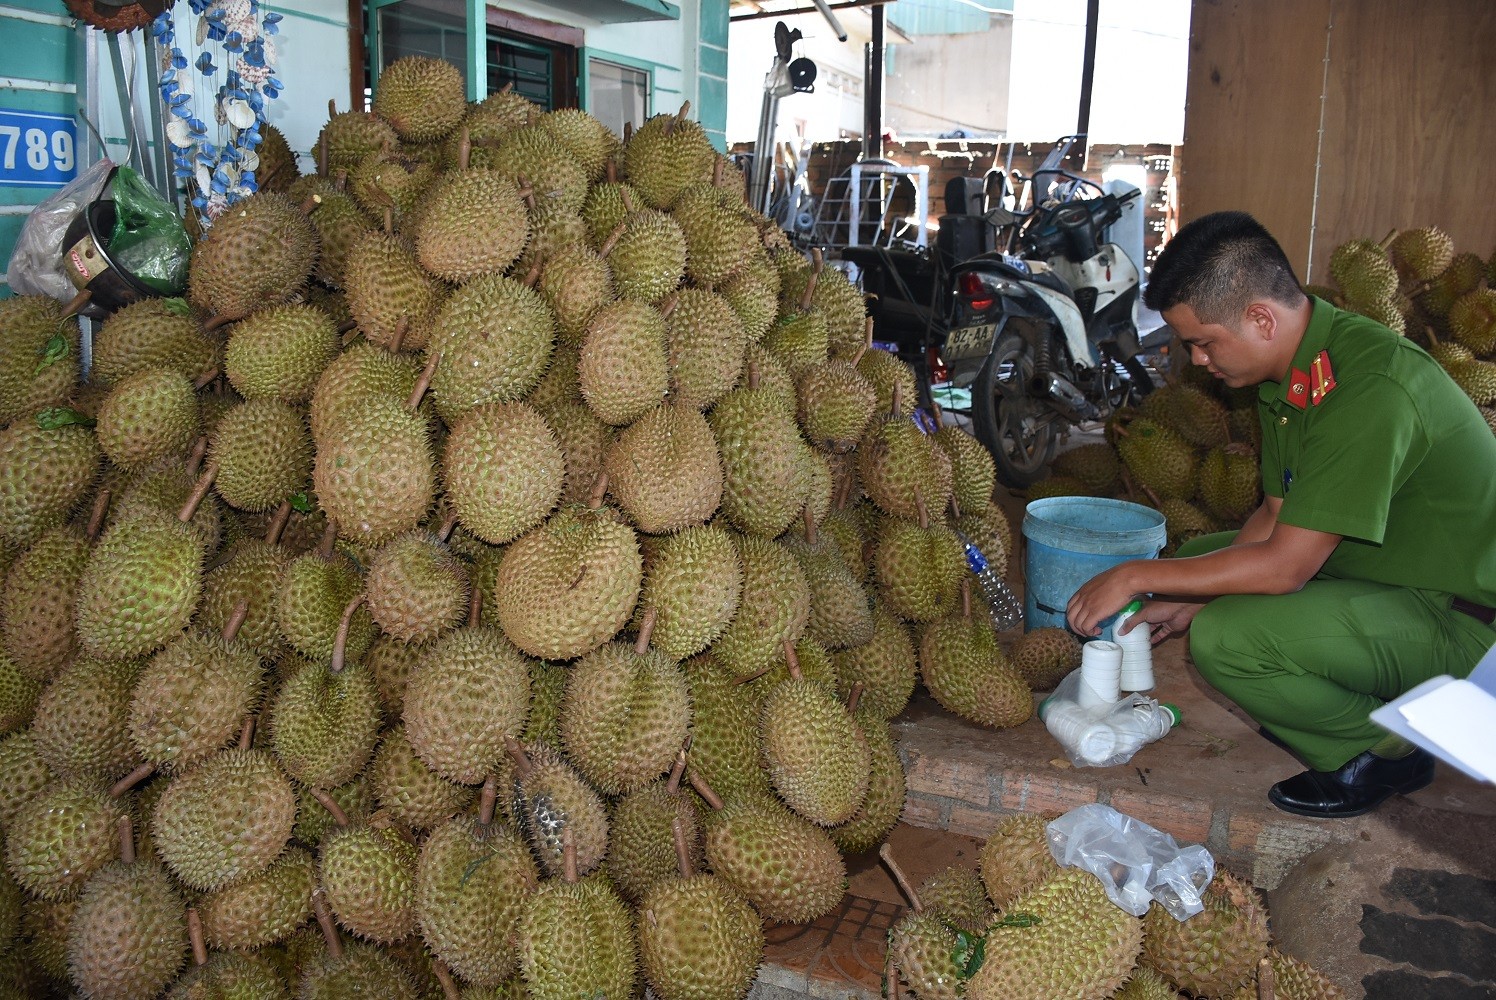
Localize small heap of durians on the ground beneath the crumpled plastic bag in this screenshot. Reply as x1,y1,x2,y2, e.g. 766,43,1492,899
880,813,1343,1000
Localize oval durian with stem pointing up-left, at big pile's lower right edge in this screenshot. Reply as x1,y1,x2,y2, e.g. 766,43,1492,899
693,778,847,924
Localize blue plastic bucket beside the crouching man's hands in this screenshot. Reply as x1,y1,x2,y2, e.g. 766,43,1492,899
1023,497,1168,639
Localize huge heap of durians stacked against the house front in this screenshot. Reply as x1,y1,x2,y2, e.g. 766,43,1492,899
0,58,1113,1000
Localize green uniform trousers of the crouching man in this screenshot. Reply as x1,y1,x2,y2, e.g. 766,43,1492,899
1177,531,1496,771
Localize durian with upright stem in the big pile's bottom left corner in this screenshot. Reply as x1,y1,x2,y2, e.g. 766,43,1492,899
67,819,187,997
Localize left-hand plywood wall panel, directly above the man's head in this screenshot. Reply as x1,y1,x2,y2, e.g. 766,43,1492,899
1179,0,1330,276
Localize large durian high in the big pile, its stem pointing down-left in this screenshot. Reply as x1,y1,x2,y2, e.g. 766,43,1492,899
426,275,555,424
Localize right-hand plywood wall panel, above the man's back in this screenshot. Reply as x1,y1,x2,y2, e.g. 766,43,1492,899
1313,0,1496,280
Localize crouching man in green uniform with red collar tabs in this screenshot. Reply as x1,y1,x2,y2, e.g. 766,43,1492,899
1068,213,1496,817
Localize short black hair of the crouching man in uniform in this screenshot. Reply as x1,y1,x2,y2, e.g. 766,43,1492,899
1143,211,1305,323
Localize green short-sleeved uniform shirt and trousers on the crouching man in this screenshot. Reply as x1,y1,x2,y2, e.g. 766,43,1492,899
1179,299,1496,771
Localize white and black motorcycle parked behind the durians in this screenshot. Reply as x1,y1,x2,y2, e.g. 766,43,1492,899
842,136,1167,488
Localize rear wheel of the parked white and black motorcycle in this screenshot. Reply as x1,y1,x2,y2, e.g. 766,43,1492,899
971,334,1059,490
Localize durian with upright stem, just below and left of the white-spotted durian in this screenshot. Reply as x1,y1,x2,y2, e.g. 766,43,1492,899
416,777,540,987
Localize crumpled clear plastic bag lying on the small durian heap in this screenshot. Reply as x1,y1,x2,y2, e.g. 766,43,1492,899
1044,802,1215,921
